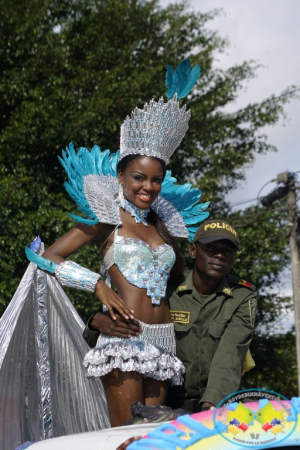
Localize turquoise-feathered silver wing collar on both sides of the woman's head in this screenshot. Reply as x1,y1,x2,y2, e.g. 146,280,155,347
59,144,209,240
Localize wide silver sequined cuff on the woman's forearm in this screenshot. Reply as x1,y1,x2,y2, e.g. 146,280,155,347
55,261,101,292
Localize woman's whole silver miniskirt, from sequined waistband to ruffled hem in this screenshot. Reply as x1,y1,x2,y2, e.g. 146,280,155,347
83,322,185,385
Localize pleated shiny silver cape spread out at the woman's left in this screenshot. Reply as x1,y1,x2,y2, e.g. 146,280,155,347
0,256,110,450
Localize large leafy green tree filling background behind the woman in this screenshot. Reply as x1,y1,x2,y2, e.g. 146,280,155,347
0,0,293,394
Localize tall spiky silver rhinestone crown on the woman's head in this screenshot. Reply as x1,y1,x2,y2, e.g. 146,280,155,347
120,94,191,164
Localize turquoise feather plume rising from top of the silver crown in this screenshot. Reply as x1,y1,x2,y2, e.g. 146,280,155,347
166,58,201,100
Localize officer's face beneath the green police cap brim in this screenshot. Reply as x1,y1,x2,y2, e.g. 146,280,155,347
189,239,236,279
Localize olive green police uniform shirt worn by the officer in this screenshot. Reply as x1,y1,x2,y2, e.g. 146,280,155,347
167,271,257,411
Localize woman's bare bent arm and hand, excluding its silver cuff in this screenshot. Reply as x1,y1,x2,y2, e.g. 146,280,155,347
43,224,134,320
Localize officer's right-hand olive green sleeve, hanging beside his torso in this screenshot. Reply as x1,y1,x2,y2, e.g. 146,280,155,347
200,292,256,405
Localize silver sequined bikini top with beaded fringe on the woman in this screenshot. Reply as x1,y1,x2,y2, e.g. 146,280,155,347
103,229,176,305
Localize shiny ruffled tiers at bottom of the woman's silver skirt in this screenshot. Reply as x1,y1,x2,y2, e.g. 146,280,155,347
83,339,185,385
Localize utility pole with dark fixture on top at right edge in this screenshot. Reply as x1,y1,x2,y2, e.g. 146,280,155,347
261,172,300,397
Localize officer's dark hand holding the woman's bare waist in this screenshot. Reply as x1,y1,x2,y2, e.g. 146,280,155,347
90,312,142,338
